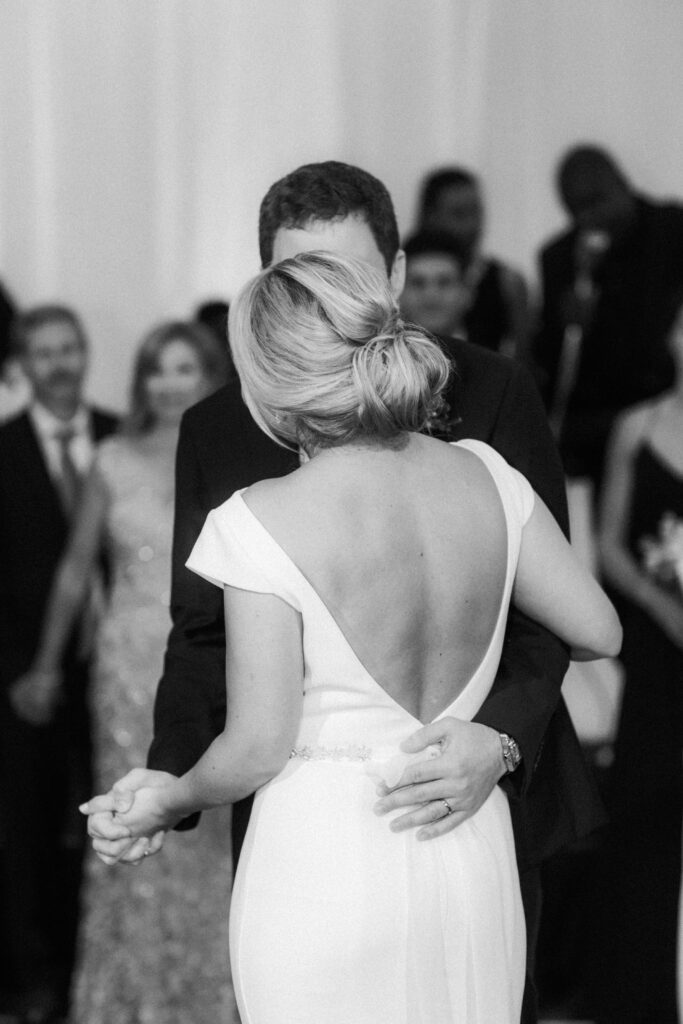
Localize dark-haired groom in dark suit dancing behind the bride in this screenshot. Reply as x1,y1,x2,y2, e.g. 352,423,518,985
89,162,601,1022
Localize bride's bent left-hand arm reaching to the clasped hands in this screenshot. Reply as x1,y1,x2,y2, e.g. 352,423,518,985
112,587,303,836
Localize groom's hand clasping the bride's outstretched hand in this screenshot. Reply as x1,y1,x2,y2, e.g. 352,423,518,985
79,768,175,864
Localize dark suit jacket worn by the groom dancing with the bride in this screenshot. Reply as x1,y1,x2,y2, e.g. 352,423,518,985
148,340,602,867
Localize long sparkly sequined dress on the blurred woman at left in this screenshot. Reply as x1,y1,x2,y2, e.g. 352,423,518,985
72,438,233,1024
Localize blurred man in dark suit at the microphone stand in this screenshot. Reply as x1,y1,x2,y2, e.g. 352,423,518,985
535,145,683,485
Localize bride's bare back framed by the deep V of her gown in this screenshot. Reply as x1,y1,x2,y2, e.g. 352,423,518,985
245,434,507,721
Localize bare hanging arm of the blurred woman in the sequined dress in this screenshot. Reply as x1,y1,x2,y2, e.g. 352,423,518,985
9,467,109,725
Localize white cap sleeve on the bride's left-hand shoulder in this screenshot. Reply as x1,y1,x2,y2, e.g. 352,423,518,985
185,502,279,594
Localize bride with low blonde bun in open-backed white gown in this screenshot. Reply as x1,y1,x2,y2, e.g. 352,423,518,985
93,253,621,1024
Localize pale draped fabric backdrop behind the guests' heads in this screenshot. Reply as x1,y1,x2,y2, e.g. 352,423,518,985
0,0,683,408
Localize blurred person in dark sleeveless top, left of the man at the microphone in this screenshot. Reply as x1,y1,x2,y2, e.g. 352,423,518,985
419,167,529,356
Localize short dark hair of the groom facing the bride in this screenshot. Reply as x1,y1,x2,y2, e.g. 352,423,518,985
258,160,399,273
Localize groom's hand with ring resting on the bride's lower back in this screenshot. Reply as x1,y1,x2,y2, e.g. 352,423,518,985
375,718,505,840
